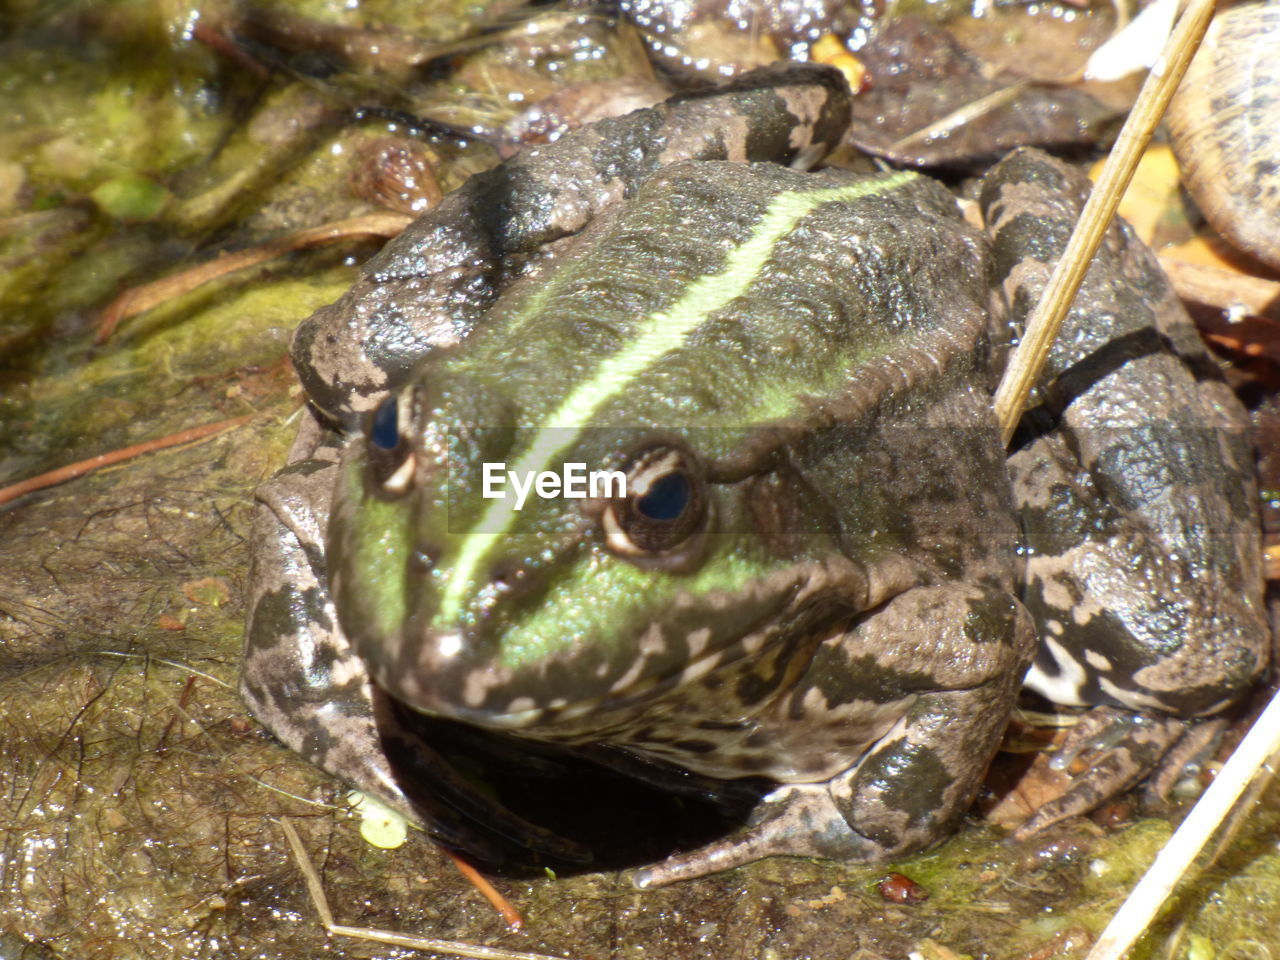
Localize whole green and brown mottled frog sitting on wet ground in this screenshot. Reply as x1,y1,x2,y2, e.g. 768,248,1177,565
241,64,1270,887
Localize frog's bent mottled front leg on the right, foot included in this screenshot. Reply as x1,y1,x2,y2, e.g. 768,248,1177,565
634,584,1034,887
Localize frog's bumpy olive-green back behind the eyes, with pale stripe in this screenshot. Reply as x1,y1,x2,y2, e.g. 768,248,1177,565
447,163,988,437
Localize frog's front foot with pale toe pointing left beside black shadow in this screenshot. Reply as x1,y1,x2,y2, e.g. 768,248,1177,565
631,783,893,890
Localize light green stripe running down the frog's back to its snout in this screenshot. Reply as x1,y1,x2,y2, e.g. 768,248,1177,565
438,170,919,625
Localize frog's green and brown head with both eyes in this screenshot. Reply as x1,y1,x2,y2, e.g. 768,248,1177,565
329,369,850,728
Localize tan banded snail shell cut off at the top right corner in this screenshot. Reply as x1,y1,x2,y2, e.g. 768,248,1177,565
1167,0,1280,270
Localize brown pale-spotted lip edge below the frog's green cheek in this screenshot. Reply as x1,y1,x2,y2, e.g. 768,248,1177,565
375,558,867,741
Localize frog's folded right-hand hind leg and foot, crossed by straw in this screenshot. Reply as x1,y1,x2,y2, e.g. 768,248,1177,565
982,151,1270,835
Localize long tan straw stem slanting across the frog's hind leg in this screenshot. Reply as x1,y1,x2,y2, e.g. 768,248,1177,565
995,0,1213,445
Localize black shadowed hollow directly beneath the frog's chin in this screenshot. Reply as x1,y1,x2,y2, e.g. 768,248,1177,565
375,696,769,870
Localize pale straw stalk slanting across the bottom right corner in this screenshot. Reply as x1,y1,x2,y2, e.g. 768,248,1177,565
1085,692,1280,960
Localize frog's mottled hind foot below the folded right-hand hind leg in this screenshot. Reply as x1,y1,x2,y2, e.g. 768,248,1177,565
1014,707,1190,840
